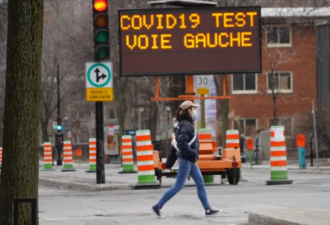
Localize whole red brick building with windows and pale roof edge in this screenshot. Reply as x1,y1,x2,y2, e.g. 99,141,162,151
223,8,330,142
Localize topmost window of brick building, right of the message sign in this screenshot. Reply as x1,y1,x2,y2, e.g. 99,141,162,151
267,26,292,47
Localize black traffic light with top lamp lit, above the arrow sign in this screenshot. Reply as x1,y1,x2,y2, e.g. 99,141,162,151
93,0,110,61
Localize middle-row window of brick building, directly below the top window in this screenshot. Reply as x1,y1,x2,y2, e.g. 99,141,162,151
267,72,292,93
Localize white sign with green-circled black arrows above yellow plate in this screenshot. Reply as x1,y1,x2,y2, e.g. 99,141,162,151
86,62,113,102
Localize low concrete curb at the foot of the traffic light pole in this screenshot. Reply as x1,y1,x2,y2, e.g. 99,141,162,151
39,177,133,192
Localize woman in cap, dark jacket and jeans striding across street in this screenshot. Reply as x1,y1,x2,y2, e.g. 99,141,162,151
151,101,220,218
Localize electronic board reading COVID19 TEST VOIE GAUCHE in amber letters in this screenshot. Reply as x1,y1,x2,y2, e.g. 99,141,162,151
119,7,261,76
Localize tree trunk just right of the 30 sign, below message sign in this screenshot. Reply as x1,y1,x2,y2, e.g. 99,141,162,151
214,75,229,148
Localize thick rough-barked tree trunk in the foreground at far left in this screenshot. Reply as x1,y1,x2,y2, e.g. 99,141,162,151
0,0,43,225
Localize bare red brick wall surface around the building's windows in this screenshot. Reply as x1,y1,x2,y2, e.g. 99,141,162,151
224,26,317,132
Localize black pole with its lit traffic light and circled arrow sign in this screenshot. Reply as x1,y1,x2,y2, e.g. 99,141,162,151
91,0,113,184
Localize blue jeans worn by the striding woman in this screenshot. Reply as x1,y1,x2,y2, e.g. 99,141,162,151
158,158,210,209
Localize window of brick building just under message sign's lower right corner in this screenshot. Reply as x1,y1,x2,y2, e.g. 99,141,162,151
232,73,257,94
